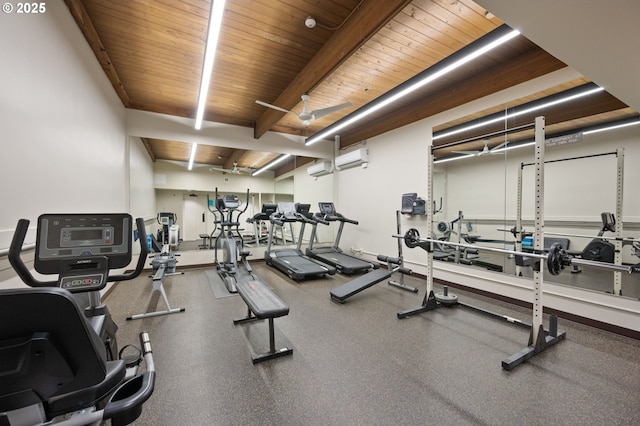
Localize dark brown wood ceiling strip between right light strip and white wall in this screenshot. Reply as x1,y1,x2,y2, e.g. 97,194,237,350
340,48,566,148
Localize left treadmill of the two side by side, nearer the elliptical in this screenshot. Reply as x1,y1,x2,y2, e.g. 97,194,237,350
264,202,336,281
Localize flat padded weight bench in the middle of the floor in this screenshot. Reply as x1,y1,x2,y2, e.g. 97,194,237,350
233,280,293,364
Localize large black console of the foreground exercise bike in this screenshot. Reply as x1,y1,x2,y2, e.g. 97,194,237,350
34,214,133,292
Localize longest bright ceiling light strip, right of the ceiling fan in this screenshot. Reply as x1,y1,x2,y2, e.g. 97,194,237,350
305,25,520,145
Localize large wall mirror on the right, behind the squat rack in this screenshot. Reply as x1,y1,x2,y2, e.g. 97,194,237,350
432,109,640,299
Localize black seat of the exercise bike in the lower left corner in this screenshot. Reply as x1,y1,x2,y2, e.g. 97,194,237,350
0,287,126,419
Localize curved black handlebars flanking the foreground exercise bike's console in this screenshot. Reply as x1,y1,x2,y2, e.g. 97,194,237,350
8,218,149,287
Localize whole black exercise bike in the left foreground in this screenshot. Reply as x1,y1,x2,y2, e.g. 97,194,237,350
0,214,155,426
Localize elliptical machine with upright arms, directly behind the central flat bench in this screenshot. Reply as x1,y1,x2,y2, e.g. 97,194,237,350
207,187,252,293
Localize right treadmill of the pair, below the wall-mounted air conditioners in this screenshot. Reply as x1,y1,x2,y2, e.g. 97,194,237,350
306,202,378,275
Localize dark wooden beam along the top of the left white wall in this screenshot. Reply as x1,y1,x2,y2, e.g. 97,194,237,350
64,0,131,108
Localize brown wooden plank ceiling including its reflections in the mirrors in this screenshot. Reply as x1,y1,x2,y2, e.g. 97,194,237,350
65,0,637,174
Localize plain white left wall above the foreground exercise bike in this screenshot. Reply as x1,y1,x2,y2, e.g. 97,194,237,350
0,1,129,286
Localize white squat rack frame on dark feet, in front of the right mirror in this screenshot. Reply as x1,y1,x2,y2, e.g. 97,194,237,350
397,116,565,370
